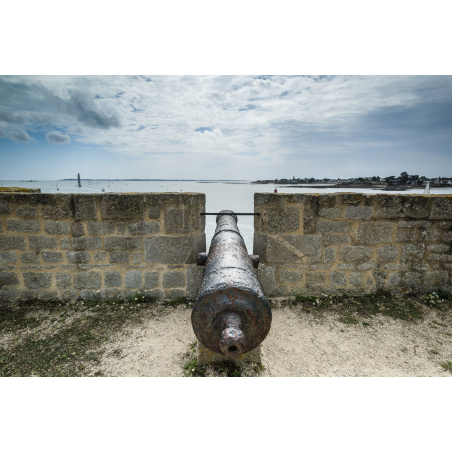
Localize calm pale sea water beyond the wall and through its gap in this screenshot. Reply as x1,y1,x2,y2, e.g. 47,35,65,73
0,180,452,253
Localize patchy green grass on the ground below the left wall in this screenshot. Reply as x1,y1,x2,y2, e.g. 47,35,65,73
0,297,161,377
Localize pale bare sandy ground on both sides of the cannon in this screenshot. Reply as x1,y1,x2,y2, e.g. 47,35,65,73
93,306,452,377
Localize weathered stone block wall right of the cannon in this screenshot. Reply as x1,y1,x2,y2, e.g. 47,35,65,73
253,193,452,296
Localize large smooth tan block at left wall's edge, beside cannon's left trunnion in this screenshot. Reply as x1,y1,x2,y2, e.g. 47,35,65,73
144,233,206,264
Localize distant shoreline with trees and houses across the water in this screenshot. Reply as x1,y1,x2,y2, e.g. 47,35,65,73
252,172,452,187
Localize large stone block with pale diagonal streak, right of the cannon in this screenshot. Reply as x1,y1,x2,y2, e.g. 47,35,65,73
253,233,322,264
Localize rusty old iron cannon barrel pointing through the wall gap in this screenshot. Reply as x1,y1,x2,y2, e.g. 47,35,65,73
191,210,272,358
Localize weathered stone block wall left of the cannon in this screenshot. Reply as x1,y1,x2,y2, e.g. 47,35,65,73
0,193,206,300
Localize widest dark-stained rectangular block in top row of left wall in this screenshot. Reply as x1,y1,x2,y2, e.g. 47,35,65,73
101,194,145,220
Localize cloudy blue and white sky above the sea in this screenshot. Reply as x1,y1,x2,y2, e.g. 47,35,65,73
0,75,452,180
